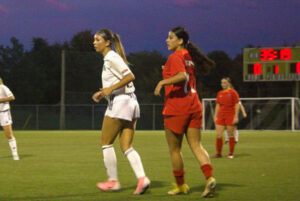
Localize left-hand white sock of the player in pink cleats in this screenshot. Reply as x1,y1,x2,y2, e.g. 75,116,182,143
102,144,118,180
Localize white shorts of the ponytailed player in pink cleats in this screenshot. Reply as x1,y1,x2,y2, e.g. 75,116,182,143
105,93,140,121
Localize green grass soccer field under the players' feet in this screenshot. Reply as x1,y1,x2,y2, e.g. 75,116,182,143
0,131,300,201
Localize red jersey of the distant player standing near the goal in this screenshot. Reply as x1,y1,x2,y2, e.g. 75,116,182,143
217,89,240,113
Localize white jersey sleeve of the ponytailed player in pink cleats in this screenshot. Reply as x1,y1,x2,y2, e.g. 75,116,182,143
108,55,131,79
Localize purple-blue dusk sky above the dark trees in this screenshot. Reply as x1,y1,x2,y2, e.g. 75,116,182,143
0,0,300,57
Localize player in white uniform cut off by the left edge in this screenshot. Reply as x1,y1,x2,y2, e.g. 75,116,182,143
0,78,19,160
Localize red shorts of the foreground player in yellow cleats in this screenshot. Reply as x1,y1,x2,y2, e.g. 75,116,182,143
164,112,202,134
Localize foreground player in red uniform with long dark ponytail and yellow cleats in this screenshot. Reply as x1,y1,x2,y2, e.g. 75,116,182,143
154,27,216,197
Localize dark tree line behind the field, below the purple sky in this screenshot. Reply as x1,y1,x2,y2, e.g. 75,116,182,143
0,30,294,104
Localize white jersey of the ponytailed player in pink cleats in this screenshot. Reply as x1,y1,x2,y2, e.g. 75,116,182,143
102,50,135,95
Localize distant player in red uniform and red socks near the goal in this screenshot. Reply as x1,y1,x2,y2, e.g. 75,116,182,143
213,77,239,159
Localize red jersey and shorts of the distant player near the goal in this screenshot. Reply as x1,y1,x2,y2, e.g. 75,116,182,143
216,89,240,126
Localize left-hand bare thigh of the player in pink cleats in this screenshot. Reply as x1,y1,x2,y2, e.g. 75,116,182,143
101,116,122,146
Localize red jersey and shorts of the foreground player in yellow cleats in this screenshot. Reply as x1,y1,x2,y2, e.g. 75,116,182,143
163,49,202,134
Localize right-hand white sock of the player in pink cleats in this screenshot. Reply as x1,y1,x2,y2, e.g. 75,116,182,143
125,147,145,178
